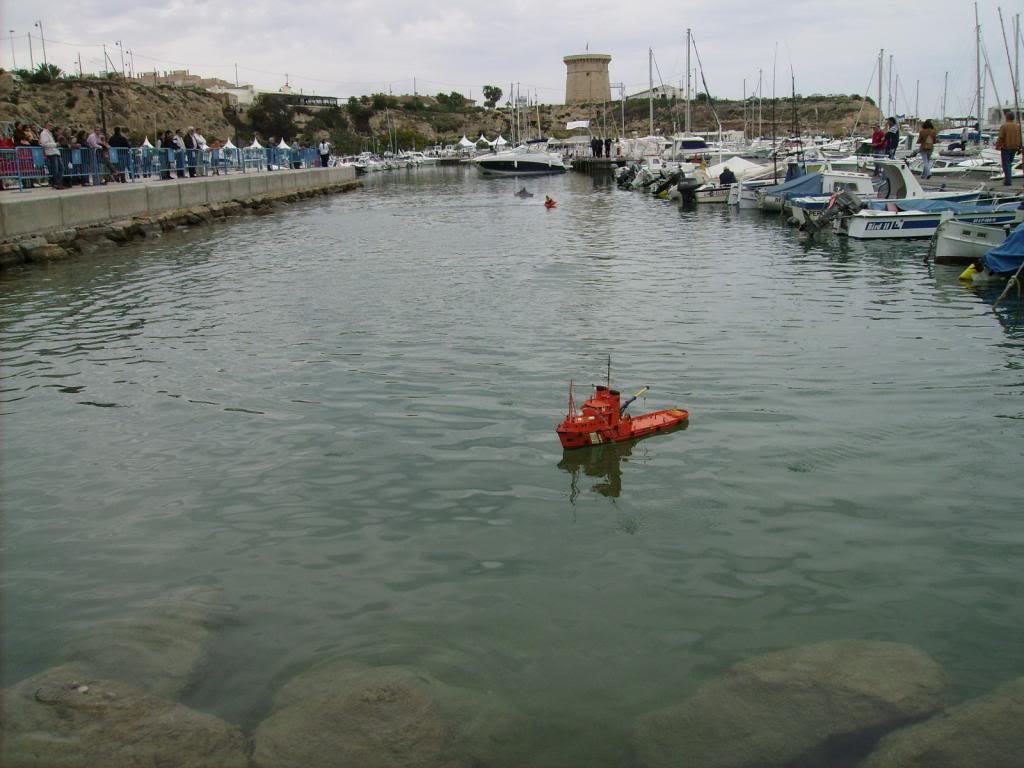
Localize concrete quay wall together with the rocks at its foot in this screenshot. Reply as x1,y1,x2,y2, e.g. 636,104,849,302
0,167,360,269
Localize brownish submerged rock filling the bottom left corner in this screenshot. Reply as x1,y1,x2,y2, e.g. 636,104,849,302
0,667,249,768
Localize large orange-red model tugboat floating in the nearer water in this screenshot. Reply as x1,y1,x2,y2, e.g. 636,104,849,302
555,376,690,449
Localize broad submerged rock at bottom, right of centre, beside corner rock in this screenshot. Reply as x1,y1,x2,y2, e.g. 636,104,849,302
634,640,945,768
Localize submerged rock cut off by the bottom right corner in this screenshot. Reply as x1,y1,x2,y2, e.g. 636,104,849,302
861,678,1024,768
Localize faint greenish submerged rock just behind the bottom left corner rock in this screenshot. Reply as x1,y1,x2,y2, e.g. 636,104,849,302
61,591,215,698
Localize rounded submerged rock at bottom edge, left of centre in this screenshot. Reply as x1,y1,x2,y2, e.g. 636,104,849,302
253,663,523,768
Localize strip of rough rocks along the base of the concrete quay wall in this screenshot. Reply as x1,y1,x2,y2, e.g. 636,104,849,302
0,181,361,270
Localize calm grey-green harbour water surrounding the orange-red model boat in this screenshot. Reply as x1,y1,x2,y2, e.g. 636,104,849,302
0,168,1024,766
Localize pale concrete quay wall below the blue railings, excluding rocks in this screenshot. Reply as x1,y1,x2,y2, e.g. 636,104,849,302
0,167,355,241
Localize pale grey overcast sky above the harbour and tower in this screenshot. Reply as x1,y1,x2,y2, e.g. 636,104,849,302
0,0,1024,116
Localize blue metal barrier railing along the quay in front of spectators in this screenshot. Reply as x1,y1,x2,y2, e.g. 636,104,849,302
0,146,321,190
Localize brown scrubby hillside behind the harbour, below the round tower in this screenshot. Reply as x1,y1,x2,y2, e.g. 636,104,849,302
0,71,879,154
